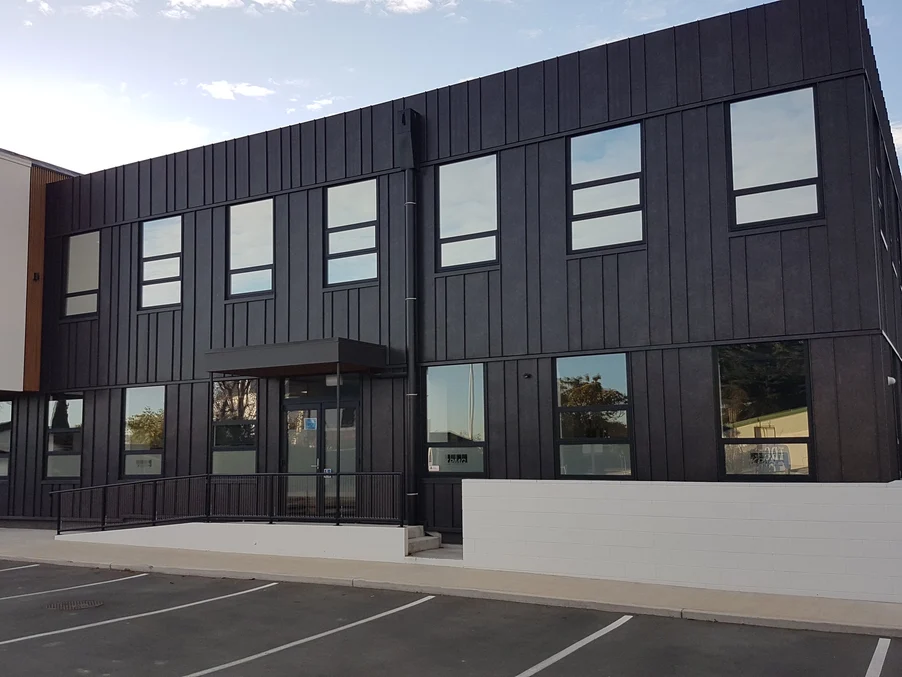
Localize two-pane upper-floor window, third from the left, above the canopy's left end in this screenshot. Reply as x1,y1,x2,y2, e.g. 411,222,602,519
229,200,273,296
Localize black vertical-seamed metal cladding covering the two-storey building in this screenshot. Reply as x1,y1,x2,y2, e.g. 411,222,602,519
0,0,902,531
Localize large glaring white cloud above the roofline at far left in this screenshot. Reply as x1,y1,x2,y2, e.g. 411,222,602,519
0,78,215,172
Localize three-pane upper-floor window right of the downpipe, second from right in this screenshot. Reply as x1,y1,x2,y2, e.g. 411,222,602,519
570,124,642,251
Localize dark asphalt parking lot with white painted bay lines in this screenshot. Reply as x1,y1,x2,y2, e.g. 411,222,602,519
0,561,902,677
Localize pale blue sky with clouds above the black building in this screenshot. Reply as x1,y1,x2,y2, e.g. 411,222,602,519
0,0,902,172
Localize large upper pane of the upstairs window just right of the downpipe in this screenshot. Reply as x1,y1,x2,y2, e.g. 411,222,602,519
439,155,498,238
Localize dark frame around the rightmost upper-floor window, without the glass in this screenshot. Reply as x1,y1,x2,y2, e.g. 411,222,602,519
724,84,826,231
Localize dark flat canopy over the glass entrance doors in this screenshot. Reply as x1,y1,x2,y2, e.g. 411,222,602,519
203,338,386,377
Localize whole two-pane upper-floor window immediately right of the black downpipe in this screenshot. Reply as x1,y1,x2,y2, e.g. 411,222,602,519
438,155,498,268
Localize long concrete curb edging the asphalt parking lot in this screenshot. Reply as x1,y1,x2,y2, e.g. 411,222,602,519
3,555,902,638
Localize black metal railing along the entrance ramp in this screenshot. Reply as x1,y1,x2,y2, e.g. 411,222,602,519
51,472,404,534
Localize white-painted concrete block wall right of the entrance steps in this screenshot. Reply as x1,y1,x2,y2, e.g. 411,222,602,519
463,480,902,602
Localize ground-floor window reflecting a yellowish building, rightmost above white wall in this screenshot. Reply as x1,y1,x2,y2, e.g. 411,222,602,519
717,341,811,477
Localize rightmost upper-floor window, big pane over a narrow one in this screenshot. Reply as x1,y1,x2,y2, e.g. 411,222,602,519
730,89,820,226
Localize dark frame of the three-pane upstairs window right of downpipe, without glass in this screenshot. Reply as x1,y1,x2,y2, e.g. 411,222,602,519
565,120,648,256
